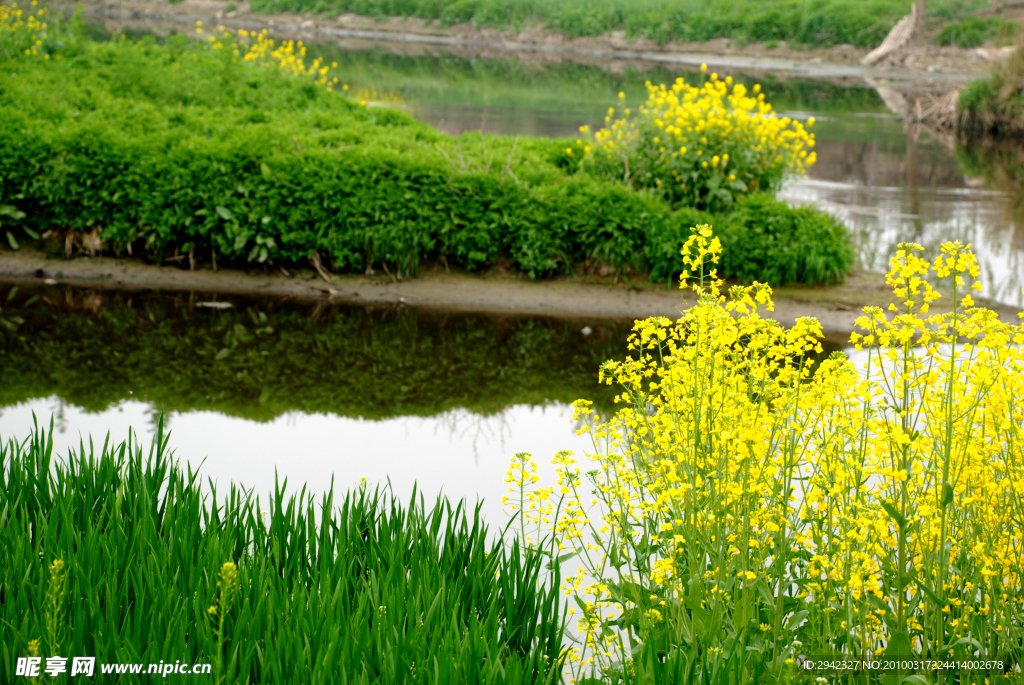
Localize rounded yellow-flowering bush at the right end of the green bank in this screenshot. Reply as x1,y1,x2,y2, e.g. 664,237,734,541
566,68,816,210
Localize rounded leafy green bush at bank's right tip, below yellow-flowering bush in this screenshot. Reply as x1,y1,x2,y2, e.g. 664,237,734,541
720,192,854,285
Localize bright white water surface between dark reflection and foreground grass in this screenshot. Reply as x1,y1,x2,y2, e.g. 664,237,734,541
0,397,591,530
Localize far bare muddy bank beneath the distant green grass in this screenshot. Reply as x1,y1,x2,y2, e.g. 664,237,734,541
66,0,991,88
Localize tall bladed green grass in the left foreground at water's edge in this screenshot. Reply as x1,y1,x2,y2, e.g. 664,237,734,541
0,419,563,685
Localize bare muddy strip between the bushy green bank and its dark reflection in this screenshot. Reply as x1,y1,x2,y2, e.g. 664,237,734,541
6,249,1018,342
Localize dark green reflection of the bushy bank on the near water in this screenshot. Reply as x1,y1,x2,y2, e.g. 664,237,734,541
0,282,628,421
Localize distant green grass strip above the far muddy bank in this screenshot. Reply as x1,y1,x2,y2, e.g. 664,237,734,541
252,0,984,47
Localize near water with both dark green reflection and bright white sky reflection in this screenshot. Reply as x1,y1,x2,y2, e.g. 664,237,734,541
0,287,630,523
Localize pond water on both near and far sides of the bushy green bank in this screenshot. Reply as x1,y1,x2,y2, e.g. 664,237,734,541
0,37,1024,523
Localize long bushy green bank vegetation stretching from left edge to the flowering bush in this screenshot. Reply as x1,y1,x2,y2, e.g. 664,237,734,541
0,13,849,286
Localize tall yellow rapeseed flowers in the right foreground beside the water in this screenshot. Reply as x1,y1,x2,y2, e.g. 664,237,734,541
516,226,1024,682
